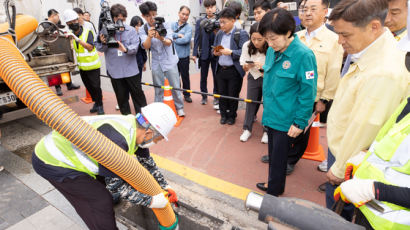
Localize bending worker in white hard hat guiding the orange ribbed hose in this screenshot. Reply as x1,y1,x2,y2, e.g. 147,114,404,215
32,102,177,230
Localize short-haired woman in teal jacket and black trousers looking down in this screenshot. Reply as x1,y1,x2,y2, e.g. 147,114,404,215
257,8,317,196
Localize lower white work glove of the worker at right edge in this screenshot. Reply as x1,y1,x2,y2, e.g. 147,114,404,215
333,178,375,208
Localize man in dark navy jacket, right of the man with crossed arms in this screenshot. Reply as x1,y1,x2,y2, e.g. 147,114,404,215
192,0,219,105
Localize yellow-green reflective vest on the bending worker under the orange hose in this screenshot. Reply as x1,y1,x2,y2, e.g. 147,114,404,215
34,115,138,178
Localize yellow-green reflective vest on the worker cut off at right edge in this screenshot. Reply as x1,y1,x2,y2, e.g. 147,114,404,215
355,97,410,230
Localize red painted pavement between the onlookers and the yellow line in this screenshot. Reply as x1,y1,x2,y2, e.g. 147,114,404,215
61,71,327,205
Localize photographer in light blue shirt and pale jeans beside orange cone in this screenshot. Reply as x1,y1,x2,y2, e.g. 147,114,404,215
139,1,185,117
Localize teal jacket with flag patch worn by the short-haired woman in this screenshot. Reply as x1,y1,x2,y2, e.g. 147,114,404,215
262,35,317,132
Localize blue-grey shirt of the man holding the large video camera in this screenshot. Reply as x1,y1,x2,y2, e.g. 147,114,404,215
95,25,139,79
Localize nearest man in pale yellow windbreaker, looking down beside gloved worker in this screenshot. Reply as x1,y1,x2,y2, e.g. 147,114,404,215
326,0,410,220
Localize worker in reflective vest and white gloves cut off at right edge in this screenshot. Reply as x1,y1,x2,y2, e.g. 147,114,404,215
334,97,410,230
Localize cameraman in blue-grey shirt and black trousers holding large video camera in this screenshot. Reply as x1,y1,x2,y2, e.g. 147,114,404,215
96,4,144,115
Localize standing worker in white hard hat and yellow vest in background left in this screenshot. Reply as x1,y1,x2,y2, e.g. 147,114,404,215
63,9,104,115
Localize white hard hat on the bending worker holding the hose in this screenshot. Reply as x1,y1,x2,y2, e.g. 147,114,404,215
141,102,177,141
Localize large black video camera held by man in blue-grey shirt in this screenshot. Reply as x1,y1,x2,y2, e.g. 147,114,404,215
98,1,124,48
